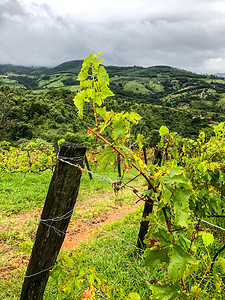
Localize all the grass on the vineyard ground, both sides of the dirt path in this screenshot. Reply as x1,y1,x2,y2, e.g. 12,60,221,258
0,166,225,300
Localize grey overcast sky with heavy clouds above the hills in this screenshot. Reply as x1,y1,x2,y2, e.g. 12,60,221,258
0,0,225,74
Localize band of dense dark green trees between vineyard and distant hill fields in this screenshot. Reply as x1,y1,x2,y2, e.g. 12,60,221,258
0,86,214,147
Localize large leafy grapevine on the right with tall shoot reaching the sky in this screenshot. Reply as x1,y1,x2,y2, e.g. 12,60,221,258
74,53,225,299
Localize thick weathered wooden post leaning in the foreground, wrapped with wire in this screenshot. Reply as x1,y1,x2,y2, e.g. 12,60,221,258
20,143,86,300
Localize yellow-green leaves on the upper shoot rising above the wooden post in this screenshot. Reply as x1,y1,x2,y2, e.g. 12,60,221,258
74,53,143,167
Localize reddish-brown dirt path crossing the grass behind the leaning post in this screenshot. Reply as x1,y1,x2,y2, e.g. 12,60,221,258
0,199,141,279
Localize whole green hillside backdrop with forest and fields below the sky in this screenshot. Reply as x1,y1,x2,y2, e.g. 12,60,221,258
0,60,225,144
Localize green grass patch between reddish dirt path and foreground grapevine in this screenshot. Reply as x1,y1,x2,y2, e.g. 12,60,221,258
46,208,151,299
